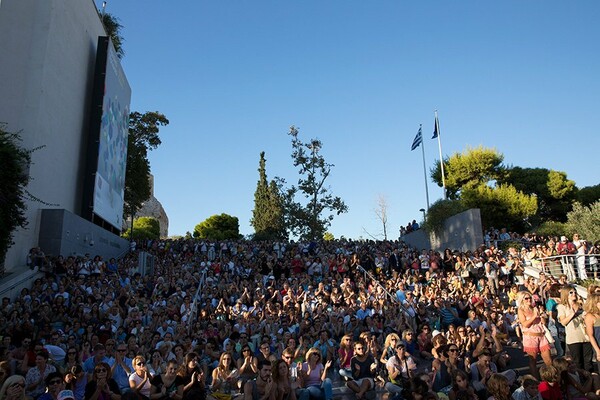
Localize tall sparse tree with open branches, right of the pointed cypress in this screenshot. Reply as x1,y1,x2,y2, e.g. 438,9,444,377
278,126,348,240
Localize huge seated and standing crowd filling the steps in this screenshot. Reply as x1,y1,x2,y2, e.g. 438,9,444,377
0,234,600,400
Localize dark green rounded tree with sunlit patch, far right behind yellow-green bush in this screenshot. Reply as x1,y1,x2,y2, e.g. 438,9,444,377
500,167,577,222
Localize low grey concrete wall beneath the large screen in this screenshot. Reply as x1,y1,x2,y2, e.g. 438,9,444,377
39,209,129,260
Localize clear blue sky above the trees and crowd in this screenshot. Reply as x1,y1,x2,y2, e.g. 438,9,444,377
97,0,600,238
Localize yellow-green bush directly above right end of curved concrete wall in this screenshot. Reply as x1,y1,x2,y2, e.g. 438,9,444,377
461,185,537,231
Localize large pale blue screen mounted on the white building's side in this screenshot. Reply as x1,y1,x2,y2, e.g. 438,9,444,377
93,41,131,231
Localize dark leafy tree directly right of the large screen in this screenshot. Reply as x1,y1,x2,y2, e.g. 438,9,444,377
123,111,169,233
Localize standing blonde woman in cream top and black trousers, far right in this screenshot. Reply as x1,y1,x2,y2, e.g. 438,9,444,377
557,286,594,371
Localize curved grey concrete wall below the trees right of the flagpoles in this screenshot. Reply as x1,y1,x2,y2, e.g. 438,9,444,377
402,208,483,252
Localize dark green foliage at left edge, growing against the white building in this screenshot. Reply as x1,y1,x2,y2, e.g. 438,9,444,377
0,124,31,265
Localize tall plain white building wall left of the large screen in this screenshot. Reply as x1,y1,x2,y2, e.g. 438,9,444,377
0,0,106,270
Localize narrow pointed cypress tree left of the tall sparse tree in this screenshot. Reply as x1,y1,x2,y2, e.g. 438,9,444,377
250,151,286,240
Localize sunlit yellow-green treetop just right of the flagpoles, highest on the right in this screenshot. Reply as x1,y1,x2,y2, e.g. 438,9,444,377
431,146,504,200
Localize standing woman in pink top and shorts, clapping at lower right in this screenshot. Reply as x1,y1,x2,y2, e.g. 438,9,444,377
517,291,552,378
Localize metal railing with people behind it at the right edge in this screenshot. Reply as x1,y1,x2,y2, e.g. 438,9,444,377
530,254,600,282
